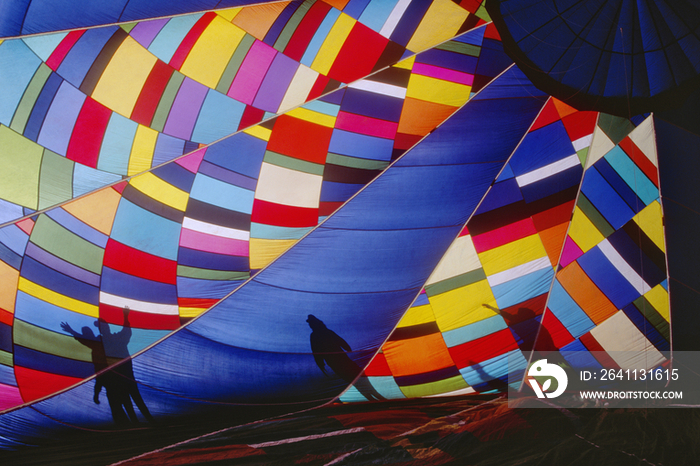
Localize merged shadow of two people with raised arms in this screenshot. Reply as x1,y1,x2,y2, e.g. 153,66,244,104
61,307,153,426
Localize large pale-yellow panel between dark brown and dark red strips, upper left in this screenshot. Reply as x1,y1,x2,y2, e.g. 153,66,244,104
92,36,157,118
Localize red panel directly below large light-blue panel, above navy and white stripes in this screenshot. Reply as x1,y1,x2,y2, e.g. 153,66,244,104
103,238,177,285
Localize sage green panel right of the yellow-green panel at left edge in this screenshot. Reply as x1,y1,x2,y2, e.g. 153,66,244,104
39,149,75,209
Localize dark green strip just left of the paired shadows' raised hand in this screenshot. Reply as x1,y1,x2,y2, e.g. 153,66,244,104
12,319,92,362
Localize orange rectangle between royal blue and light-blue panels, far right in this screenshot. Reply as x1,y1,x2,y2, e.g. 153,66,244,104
557,262,618,325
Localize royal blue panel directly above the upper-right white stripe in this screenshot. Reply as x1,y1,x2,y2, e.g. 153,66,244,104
509,120,576,176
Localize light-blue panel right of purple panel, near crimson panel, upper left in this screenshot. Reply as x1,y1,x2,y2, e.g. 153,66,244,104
192,89,245,144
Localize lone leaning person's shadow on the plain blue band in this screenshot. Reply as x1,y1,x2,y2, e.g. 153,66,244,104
306,314,385,401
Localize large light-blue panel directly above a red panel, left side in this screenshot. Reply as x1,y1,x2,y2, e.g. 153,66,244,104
111,198,181,260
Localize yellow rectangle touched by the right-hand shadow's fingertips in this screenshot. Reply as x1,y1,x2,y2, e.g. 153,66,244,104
430,280,498,332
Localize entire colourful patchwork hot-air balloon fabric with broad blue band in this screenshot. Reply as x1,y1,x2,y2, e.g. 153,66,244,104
0,0,700,456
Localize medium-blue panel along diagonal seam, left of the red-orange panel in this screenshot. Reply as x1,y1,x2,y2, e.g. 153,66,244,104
204,133,267,180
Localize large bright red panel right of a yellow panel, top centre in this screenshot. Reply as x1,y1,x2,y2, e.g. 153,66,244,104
328,23,389,83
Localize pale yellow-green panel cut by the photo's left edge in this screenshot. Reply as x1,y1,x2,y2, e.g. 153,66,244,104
0,125,44,210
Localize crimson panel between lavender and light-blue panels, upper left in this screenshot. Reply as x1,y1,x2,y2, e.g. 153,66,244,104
66,97,112,168
